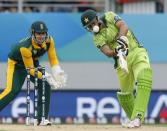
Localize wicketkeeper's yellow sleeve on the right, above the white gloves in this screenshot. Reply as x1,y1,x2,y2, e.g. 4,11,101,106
48,37,59,66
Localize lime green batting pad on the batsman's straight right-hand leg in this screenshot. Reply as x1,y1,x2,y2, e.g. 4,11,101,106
131,68,152,122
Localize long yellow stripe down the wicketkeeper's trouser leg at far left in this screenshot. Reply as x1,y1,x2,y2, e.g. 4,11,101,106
0,59,16,99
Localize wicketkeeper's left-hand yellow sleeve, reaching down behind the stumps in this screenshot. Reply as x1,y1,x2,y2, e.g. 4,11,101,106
20,47,42,79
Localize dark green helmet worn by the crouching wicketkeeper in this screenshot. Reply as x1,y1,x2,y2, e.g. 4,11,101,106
31,21,48,34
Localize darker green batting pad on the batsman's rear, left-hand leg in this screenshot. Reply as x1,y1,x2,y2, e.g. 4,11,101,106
117,92,134,119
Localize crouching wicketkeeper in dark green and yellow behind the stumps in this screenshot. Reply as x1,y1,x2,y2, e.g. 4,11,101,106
0,21,67,126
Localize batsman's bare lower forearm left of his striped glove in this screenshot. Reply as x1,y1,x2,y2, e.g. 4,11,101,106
100,44,116,57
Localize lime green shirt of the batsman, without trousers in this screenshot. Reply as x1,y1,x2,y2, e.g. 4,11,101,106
93,12,139,51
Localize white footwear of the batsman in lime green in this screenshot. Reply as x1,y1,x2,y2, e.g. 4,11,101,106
122,118,141,128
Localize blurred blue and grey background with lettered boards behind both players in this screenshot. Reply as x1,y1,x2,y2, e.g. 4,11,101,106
0,0,167,124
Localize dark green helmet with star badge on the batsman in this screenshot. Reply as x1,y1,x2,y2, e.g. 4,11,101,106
81,9,97,27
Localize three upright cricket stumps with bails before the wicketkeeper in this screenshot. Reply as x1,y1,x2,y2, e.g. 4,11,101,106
26,67,46,126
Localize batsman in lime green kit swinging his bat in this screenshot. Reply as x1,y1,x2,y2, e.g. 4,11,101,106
81,9,152,128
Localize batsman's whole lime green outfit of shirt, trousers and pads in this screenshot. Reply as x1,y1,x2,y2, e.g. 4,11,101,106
91,12,152,121
